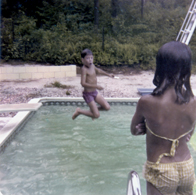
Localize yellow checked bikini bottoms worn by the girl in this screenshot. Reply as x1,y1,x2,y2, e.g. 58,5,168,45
144,158,195,195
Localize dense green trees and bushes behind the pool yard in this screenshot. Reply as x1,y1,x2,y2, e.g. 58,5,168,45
1,0,196,69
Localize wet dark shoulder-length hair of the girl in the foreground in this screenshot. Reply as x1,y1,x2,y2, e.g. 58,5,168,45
152,41,194,104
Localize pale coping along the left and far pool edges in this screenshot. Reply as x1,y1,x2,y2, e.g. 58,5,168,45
0,97,139,152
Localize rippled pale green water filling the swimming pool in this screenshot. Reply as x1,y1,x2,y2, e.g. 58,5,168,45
0,99,196,195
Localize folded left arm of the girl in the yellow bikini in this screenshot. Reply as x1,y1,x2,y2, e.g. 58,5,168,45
130,98,146,135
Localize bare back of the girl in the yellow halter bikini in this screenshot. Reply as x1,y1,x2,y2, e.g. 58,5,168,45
140,87,196,162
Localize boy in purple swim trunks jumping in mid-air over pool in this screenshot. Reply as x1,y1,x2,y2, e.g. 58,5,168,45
72,49,114,120
